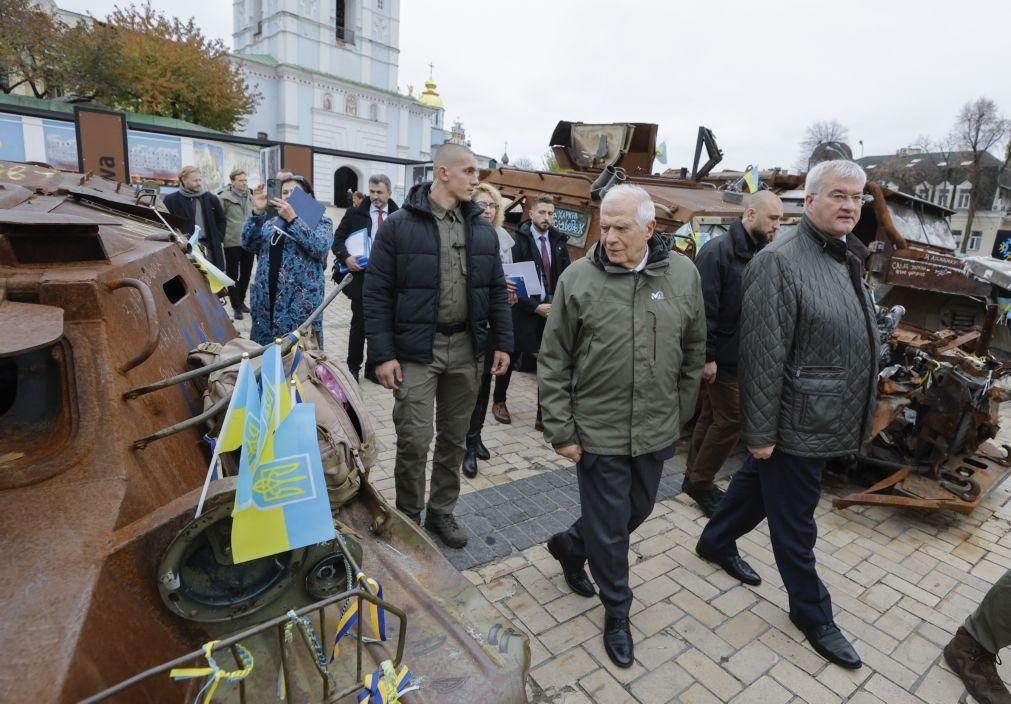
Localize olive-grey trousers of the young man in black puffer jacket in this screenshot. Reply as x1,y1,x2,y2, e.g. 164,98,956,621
393,333,483,518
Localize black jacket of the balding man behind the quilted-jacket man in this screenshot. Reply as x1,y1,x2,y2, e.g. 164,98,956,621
696,218,755,376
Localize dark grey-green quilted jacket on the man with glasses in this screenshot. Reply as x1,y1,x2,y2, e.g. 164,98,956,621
739,216,878,457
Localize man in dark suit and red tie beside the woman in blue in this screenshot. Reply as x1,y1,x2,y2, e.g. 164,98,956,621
332,174,397,383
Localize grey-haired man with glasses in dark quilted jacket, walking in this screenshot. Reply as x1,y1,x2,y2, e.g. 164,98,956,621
696,160,878,669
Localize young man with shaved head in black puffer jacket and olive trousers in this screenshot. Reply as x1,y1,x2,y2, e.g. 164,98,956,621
365,144,513,547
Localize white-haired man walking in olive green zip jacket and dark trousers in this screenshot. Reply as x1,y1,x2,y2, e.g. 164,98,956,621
537,185,706,668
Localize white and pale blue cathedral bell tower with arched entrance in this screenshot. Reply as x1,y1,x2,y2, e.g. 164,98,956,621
233,0,442,206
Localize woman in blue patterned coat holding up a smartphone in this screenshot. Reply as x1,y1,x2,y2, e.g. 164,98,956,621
243,176,334,349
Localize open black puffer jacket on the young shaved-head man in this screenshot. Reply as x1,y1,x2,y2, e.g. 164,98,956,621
364,183,513,364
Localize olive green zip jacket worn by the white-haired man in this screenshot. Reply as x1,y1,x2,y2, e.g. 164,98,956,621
537,238,706,456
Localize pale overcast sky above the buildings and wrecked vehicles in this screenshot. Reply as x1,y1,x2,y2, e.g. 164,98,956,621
58,0,1011,168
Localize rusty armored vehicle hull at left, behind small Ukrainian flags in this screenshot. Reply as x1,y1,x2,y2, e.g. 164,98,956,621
0,163,530,702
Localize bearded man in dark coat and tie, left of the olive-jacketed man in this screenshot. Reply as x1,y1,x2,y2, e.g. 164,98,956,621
491,193,571,430
